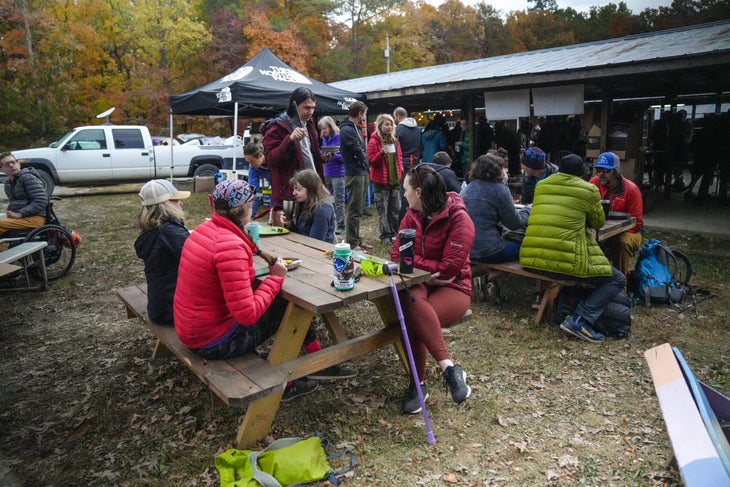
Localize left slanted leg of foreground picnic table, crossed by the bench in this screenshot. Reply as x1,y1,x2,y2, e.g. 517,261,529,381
236,303,314,449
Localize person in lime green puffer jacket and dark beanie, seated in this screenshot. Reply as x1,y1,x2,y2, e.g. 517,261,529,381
520,154,626,342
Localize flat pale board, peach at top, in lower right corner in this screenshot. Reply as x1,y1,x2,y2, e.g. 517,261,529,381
644,343,730,487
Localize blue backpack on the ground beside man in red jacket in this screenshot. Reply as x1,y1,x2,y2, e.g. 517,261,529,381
632,239,692,306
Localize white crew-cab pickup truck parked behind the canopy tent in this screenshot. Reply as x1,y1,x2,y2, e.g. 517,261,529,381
13,124,245,194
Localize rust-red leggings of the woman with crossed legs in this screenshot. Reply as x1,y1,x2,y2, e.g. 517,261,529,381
400,284,471,380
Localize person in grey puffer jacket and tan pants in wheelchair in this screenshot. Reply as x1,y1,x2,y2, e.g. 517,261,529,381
0,152,48,236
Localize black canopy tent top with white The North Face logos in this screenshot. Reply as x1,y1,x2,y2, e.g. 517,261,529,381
170,47,365,118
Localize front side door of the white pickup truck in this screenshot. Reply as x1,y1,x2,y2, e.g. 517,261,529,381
56,128,112,183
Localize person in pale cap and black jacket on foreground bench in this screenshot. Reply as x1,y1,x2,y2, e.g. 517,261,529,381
134,179,190,325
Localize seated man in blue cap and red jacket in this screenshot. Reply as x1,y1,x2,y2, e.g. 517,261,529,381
589,152,644,274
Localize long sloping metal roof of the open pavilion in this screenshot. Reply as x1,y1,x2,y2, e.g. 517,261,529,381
330,20,730,110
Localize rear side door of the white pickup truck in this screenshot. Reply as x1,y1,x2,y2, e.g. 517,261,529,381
111,127,154,181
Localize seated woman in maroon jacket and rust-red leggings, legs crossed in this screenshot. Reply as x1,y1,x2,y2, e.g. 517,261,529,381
390,164,474,414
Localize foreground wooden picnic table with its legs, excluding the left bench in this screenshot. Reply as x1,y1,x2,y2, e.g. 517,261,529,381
237,233,430,448
